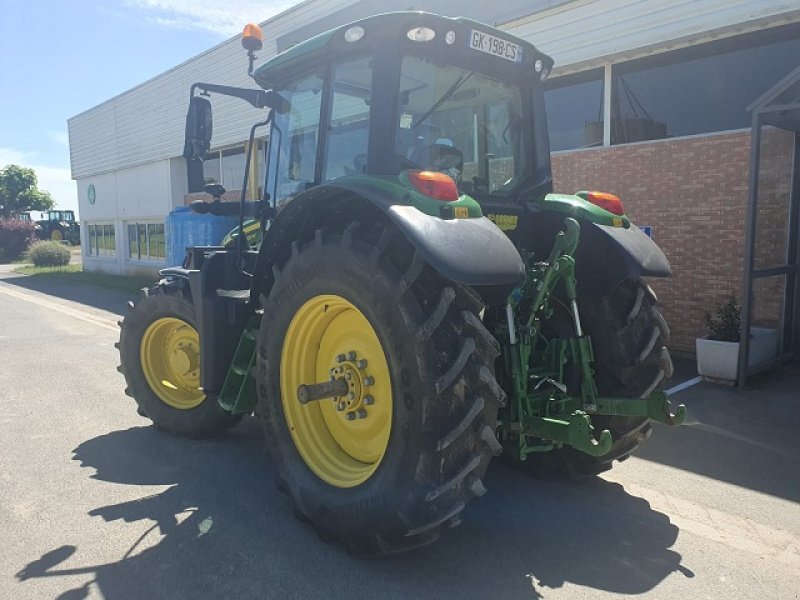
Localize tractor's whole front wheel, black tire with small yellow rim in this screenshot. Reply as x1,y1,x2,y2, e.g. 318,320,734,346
117,280,241,437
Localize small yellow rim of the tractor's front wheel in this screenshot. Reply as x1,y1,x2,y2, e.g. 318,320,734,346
140,317,205,410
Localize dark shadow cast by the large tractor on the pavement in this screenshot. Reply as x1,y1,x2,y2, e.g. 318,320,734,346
17,419,693,600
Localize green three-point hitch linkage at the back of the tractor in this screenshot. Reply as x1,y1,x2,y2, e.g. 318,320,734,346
495,218,686,461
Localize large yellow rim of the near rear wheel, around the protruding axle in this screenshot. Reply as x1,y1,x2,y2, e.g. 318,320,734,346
281,295,392,488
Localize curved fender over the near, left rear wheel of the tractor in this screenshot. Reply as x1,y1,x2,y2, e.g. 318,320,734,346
251,177,525,301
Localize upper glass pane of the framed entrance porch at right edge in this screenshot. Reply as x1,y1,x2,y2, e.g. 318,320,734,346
753,127,794,269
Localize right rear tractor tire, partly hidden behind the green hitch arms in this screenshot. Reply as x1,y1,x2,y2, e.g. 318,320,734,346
526,278,673,479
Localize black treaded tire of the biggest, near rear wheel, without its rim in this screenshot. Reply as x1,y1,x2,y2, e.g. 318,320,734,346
256,223,503,555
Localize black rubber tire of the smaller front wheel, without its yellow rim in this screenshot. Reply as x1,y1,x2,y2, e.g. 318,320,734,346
116,279,241,438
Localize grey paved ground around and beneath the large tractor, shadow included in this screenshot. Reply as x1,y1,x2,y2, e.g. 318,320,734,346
0,273,800,600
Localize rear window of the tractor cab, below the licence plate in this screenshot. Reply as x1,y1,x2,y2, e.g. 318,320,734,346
395,56,525,193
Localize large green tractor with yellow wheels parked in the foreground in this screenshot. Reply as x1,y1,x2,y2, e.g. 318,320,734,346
118,12,685,555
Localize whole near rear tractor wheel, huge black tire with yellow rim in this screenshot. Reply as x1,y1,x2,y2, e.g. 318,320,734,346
257,224,502,554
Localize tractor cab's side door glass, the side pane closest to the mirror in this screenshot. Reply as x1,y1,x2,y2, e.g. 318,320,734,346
270,75,323,207
